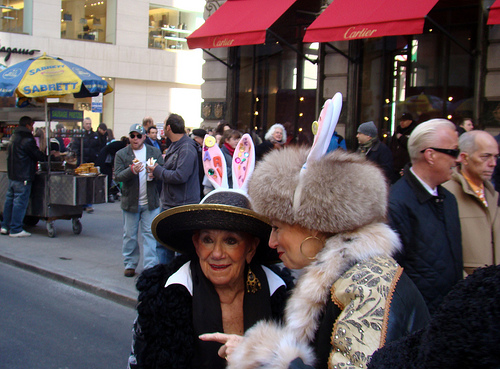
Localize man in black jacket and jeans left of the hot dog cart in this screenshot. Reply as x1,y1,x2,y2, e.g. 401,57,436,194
1,116,47,237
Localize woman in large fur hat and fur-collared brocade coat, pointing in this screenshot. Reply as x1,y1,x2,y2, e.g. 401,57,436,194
201,148,429,369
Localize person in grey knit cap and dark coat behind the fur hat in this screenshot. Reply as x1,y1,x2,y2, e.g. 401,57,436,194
356,121,394,183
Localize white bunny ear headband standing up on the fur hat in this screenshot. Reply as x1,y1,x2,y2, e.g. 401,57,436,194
293,92,342,211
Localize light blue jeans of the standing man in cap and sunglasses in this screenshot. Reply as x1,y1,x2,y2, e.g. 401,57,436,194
122,205,160,269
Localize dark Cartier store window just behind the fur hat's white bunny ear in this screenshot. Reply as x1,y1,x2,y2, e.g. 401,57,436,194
236,44,318,143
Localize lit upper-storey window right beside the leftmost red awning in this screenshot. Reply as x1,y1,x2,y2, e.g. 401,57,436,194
148,4,203,50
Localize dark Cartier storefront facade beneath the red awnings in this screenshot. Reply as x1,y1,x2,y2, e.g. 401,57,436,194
195,0,500,148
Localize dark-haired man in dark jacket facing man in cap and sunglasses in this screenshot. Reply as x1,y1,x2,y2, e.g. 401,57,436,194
149,114,201,264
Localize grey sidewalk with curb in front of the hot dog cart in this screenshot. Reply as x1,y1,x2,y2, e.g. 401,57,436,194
0,201,142,307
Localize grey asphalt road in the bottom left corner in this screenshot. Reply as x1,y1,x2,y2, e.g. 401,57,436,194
0,263,135,369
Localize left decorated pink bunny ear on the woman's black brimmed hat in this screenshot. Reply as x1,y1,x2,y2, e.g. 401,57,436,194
203,135,228,189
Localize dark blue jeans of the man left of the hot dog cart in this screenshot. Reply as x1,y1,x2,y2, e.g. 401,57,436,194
2,179,31,234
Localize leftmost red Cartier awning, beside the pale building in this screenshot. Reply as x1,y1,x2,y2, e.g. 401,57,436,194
187,0,296,49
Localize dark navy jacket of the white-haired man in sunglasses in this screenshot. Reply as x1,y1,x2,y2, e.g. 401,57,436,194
389,170,463,314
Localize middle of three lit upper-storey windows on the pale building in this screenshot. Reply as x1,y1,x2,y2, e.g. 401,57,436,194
61,0,116,43
